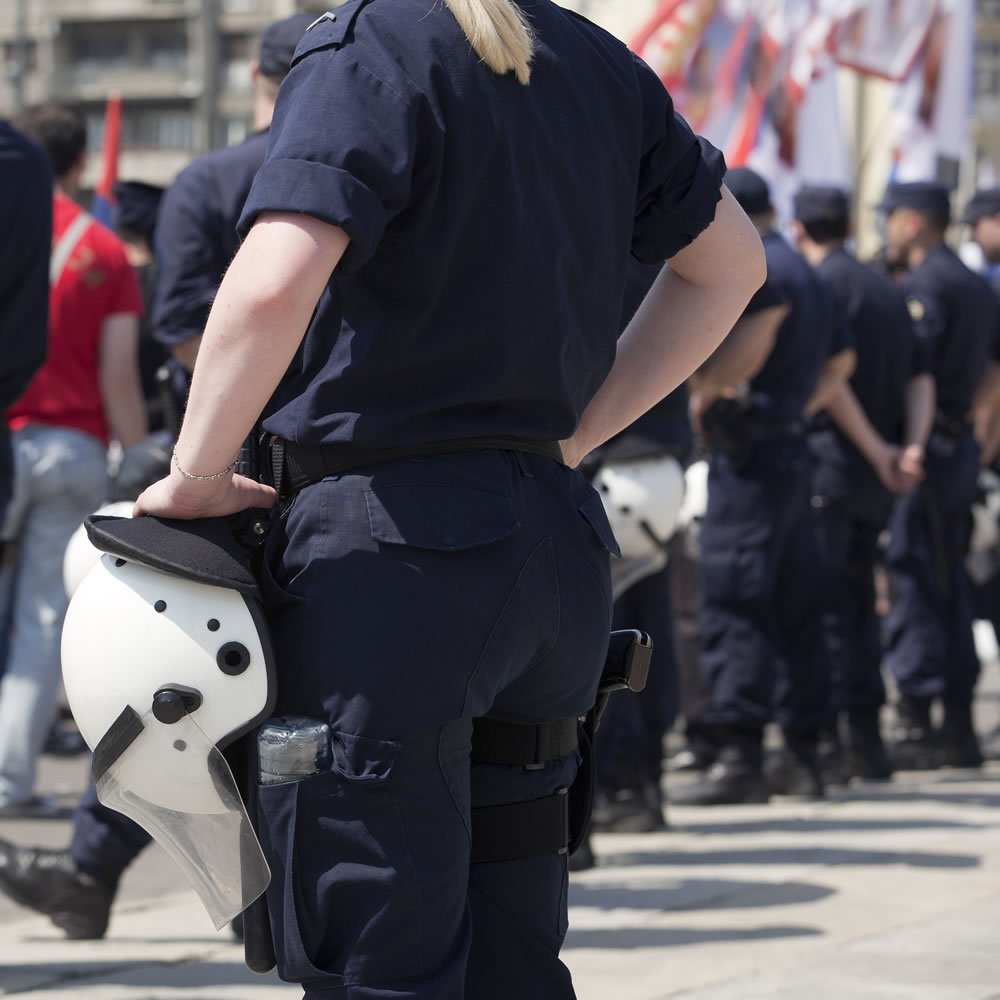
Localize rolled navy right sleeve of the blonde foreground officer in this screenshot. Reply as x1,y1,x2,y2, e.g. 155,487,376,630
632,56,726,264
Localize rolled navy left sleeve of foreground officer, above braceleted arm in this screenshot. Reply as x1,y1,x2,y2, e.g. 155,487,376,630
238,47,417,273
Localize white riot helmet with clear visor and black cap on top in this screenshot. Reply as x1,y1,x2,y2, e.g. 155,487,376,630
62,516,274,927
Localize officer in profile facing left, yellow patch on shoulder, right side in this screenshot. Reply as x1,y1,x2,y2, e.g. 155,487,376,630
879,181,997,769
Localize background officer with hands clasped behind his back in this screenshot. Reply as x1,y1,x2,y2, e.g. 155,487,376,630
792,187,934,779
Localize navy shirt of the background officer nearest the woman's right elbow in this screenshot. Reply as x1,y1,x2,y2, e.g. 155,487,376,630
748,232,852,423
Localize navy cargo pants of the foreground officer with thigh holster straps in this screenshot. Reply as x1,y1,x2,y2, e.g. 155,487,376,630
259,451,616,1000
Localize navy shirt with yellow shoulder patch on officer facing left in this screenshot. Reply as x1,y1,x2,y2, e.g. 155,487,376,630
903,243,998,419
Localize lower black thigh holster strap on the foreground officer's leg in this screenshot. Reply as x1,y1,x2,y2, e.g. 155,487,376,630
472,788,569,864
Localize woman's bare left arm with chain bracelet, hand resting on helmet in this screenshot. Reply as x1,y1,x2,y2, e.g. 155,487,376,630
135,212,349,518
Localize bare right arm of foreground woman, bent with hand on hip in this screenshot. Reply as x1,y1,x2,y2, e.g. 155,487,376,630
562,187,766,466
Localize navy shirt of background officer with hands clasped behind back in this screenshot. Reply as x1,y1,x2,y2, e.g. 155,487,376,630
810,243,930,510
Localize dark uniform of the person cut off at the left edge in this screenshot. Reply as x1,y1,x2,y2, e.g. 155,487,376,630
0,121,52,524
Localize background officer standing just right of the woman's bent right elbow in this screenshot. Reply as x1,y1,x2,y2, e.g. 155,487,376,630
671,168,853,805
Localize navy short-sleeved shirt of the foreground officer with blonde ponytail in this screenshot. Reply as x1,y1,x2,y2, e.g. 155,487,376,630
240,0,725,451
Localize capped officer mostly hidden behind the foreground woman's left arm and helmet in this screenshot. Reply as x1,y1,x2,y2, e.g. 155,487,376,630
0,14,315,939
